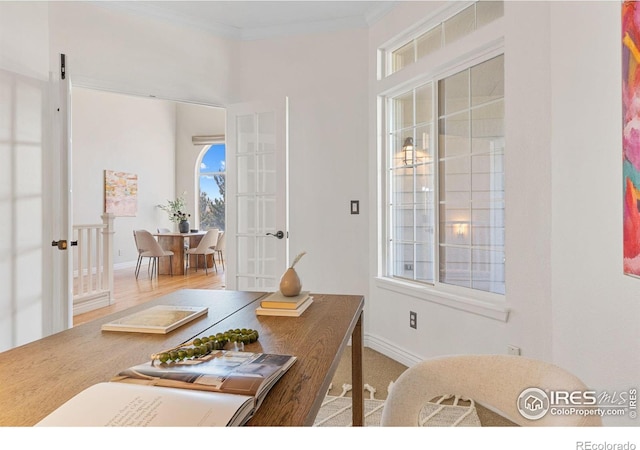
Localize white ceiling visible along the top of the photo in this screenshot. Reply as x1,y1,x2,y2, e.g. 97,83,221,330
95,0,396,40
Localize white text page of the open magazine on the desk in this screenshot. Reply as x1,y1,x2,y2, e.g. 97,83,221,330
36,382,254,427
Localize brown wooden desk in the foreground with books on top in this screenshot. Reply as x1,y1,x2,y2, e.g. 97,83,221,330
0,289,364,426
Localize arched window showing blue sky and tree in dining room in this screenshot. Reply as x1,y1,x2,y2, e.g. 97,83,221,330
198,143,226,231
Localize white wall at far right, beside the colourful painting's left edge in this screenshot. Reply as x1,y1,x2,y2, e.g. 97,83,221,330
550,1,640,425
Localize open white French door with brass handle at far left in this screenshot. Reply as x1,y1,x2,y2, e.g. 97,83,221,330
0,55,72,351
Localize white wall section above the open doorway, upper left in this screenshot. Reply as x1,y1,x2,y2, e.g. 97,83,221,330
48,2,232,105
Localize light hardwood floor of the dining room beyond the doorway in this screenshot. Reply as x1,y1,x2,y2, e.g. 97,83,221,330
73,262,225,326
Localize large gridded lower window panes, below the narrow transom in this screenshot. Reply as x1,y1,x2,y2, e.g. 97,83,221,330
386,55,505,294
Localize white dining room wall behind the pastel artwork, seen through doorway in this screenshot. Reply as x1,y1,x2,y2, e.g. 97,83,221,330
72,88,176,264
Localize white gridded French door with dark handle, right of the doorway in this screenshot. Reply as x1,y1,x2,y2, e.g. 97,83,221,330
226,98,289,291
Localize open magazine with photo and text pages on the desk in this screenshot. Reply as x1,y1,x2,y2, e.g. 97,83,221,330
36,350,296,427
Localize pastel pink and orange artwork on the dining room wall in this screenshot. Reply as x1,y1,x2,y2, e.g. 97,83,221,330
104,170,138,216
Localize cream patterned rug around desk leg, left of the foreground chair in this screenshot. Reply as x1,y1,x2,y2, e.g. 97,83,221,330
313,384,384,427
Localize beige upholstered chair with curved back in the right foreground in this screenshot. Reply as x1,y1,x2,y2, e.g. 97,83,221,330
381,355,602,426
